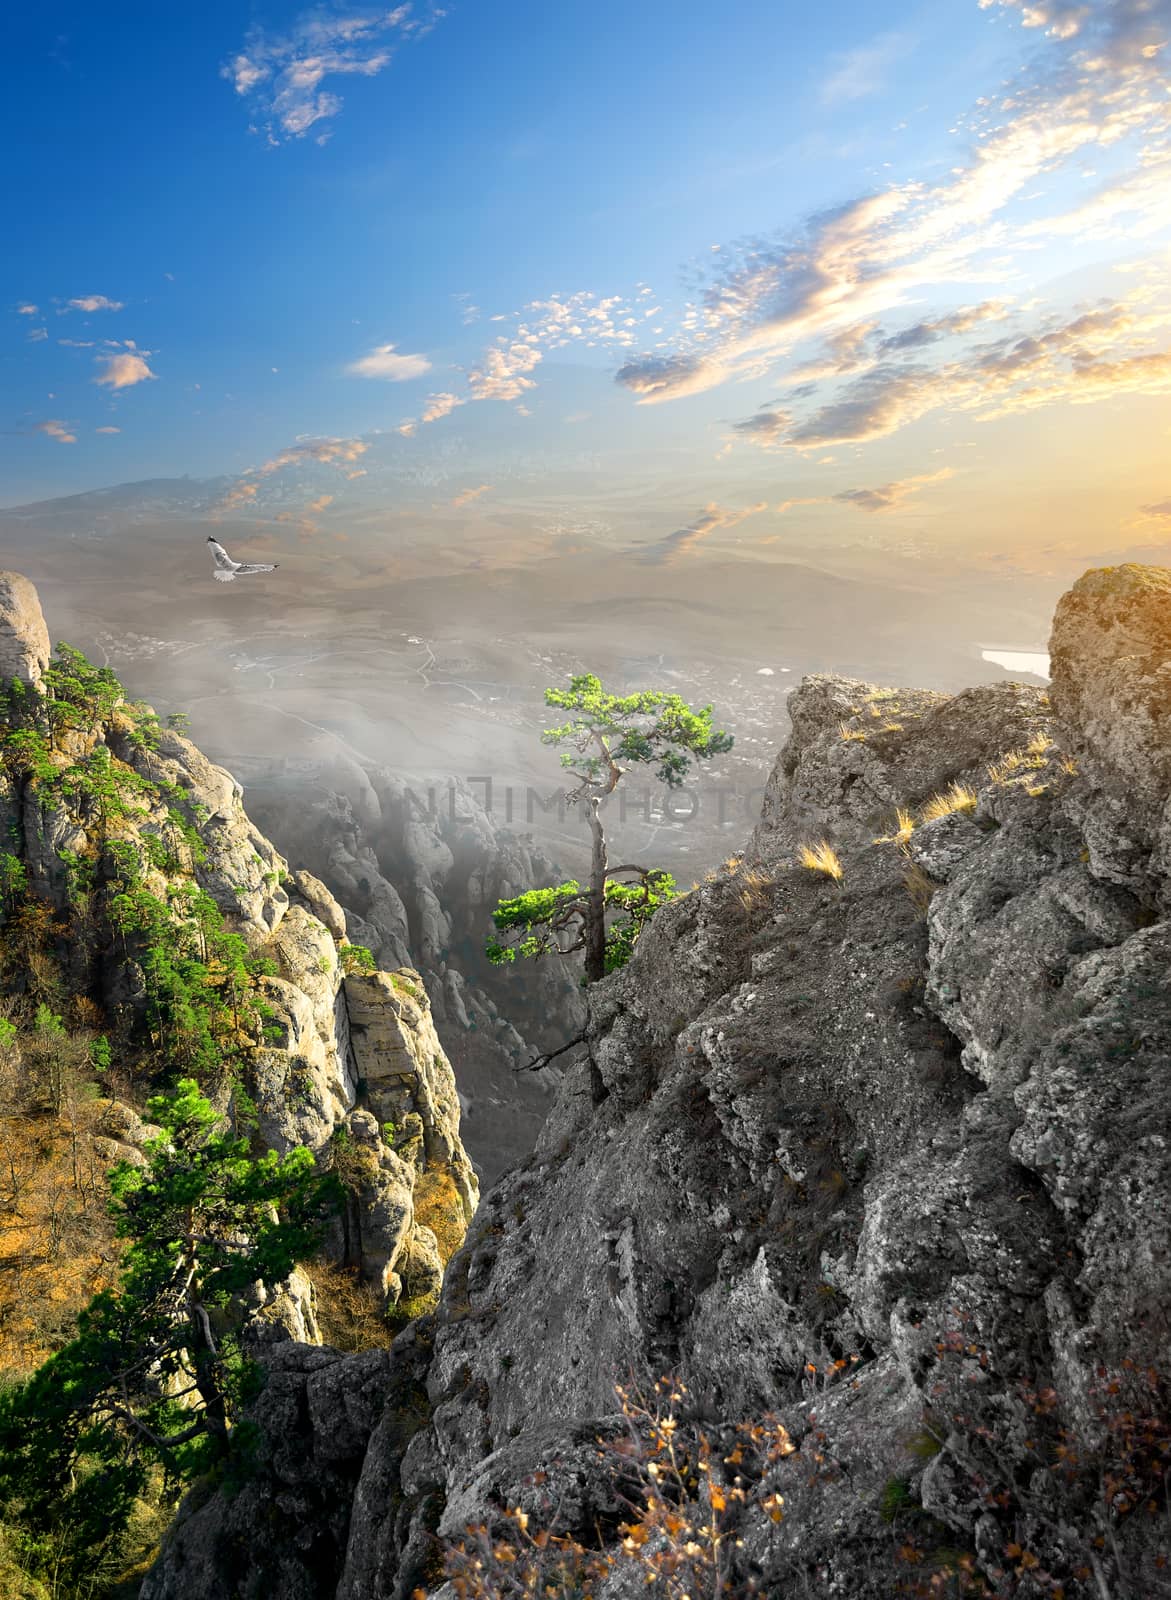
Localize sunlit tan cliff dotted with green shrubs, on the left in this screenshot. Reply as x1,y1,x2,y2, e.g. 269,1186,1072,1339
0,573,477,1334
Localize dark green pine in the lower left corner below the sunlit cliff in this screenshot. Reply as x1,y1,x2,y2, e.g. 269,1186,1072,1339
0,1080,338,1579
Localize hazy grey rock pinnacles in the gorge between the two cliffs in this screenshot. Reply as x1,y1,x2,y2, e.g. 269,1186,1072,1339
254,768,584,1182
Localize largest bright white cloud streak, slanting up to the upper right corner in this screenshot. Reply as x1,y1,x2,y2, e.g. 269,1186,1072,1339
616,0,1171,405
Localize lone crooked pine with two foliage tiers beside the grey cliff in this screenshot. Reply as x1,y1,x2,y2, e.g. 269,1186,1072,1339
486,672,733,984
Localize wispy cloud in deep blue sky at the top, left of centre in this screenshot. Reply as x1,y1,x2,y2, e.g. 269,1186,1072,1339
221,5,443,144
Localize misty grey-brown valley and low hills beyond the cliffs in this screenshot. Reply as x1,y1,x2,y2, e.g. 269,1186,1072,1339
0,467,1077,882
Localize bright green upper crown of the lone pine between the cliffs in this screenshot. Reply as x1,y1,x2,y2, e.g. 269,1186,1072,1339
541,672,733,787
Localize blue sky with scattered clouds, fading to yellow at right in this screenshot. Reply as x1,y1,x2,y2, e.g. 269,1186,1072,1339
0,0,1171,558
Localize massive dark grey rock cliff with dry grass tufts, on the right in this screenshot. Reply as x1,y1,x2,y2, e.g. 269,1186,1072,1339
105,566,1171,1600
